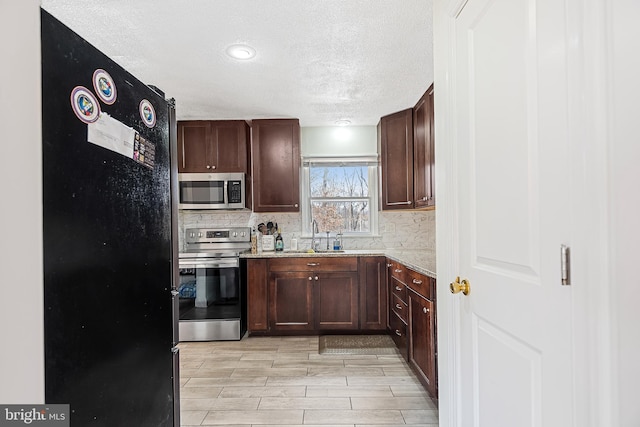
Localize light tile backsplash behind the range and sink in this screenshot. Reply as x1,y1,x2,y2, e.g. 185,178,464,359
178,210,436,250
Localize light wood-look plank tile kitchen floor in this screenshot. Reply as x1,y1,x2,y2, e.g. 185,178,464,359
179,337,438,427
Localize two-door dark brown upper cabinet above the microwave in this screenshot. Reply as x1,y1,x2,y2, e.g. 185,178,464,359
178,120,250,173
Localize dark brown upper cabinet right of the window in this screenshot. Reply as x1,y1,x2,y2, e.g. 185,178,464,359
378,85,435,210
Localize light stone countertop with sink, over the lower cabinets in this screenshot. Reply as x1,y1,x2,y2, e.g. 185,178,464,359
240,249,436,279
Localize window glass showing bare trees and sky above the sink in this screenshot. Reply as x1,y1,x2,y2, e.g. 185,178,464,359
309,164,371,233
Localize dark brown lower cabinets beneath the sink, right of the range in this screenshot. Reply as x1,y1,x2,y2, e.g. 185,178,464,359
246,256,388,335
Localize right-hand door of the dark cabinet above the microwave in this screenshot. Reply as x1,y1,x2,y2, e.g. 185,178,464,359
210,120,249,173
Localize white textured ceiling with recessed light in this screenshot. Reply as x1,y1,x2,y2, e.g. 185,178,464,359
42,0,433,126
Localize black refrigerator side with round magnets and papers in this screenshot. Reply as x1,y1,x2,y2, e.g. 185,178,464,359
41,10,179,427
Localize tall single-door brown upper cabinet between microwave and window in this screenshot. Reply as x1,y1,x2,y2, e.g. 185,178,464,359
251,119,300,212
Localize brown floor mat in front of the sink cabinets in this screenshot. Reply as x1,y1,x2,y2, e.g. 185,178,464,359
318,335,398,354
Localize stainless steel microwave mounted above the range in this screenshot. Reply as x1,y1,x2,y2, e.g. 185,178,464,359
178,173,245,209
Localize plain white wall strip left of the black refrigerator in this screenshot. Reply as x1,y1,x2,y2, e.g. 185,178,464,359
0,0,44,404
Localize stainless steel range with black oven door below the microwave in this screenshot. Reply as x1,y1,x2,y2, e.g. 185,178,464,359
178,227,251,341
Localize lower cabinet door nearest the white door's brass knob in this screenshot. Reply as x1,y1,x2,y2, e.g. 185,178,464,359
409,291,438,399
